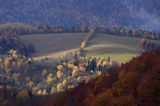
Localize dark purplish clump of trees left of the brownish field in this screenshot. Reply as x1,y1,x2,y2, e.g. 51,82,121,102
0,31,35,56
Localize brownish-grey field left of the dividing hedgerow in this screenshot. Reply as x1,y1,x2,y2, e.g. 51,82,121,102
21,33,87,57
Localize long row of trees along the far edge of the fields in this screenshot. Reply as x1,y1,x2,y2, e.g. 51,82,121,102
0,22,160,40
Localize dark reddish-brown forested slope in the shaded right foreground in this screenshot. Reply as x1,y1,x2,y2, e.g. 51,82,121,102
46,50,160,106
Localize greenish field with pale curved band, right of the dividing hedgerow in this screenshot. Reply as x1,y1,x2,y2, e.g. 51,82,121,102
85,33,160,63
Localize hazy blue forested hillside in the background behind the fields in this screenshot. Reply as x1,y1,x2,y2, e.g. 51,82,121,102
0,0,160,31
